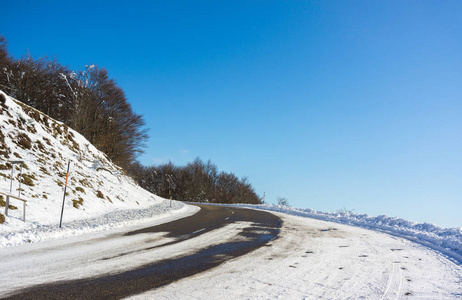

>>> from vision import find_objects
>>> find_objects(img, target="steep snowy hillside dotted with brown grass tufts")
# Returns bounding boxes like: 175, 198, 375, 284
0, 91, 184, 246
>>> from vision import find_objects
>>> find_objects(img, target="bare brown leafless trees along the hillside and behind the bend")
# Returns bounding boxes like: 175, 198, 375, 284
0, 35, 261, 203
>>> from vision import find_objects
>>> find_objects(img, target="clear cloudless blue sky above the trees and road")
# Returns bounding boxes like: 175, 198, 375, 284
0, 0, 462, 227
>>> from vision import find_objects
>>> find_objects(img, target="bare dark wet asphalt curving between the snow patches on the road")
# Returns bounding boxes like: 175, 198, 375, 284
3, 205, 282, 299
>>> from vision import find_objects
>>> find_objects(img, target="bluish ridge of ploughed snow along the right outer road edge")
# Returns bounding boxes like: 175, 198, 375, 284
238, 204, 462, 264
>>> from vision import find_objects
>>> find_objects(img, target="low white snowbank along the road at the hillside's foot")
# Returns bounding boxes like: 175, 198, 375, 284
0, 201, 199, 247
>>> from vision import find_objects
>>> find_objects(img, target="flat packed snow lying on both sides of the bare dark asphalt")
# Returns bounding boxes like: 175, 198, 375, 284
0, 206, 462, 299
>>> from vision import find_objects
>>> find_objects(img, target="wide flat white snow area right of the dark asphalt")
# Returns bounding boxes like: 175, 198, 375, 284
130, 213, 462, 300
